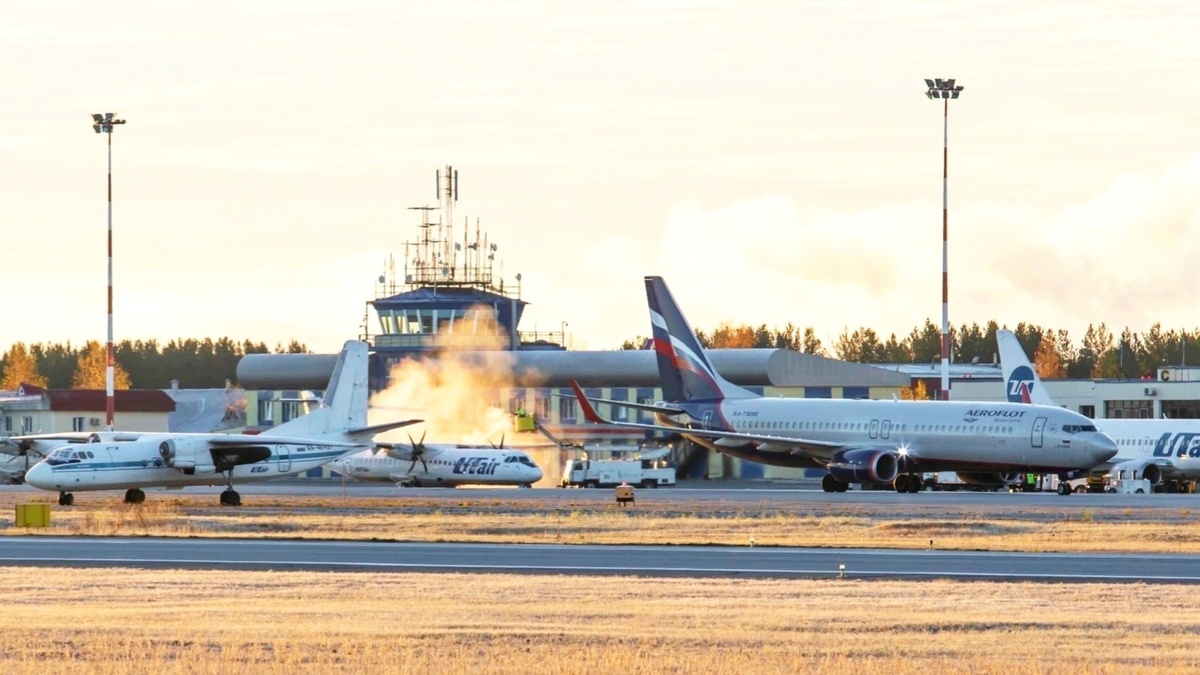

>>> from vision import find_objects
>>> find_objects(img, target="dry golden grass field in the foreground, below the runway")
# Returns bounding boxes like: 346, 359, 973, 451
0, 568, 1200, 675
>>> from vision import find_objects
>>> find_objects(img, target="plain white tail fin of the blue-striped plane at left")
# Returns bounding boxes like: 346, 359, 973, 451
265, 340, 370, 437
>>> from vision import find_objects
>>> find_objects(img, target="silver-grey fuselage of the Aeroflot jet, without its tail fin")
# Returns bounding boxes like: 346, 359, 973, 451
698, 398, 1116, 471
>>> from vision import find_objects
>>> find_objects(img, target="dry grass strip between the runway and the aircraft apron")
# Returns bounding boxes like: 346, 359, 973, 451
0, 490, 1200, 552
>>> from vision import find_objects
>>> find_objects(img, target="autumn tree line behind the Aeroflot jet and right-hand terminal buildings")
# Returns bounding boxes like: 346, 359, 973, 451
622, 319, 1200, 380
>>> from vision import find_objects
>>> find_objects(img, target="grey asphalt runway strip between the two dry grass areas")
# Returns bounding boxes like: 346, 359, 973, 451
0, 537, 1200, 584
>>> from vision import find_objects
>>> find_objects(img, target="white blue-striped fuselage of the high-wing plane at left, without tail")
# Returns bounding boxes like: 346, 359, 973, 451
25, 436, 360, 492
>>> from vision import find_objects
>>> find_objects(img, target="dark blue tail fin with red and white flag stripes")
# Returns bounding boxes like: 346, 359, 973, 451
646, 276, 754, 401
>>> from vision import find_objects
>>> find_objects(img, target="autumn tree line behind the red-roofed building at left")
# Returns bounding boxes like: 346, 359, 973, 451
0, 338, 308, 392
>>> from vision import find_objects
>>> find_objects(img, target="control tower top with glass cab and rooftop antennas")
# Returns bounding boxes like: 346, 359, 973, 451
362, 166, 564, 368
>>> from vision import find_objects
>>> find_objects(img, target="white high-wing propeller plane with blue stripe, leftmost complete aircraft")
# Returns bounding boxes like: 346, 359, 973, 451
12, 340, 420, 506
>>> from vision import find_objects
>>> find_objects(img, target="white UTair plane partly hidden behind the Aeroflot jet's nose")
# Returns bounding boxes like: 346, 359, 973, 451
996, 329, 1200, 494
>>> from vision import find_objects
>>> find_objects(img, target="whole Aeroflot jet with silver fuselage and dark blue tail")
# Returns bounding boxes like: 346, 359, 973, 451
572, 276, 1117, 492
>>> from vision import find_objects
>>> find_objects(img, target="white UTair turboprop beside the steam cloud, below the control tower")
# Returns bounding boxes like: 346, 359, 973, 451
329, 436, 541, 488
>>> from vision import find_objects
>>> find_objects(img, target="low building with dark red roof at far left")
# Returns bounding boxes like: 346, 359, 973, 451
0, 384, 175, 436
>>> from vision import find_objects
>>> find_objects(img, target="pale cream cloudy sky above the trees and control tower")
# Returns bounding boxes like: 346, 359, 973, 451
0, 0, 1200, 353
